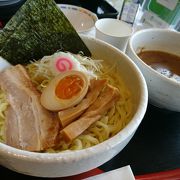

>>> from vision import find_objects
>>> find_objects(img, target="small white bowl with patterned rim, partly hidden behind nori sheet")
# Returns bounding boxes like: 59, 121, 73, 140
58, 4, 98, 33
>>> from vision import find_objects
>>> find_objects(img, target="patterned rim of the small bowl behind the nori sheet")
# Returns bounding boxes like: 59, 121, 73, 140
57, 4, 98, 33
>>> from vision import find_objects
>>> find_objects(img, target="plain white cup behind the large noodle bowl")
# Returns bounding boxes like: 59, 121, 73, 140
95, 18, 132, 52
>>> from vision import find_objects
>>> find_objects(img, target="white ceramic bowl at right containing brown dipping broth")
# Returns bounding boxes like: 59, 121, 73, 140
126, 29, 180, 112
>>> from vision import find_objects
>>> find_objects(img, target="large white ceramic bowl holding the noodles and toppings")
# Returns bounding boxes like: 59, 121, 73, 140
0, 37, 148, 177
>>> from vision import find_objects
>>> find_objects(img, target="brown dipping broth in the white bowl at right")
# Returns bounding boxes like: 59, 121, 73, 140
137, 50, 180, 81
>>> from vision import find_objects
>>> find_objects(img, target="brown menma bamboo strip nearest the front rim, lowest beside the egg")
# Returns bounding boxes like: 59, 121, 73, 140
60, 84, 120, 142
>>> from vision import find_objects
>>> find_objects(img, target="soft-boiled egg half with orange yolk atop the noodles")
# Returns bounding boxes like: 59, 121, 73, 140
40, 70, 89, 111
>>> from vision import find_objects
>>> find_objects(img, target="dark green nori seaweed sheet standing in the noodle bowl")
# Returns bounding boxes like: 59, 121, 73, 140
0, 0, 91, 64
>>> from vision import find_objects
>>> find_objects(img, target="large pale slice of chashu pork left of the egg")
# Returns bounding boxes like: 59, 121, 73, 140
0, 65, 59, 151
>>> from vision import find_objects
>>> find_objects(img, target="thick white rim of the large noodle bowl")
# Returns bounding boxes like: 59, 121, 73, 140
0, 35, 148, 163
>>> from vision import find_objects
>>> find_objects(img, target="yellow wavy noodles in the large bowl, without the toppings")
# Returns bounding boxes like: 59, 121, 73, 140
0, 54, 132, 152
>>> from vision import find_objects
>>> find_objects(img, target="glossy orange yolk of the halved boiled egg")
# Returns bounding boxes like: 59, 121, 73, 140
55, 75, 84, 99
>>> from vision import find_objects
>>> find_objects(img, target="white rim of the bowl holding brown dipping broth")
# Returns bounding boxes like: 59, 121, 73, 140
128, 28, 180, 87
